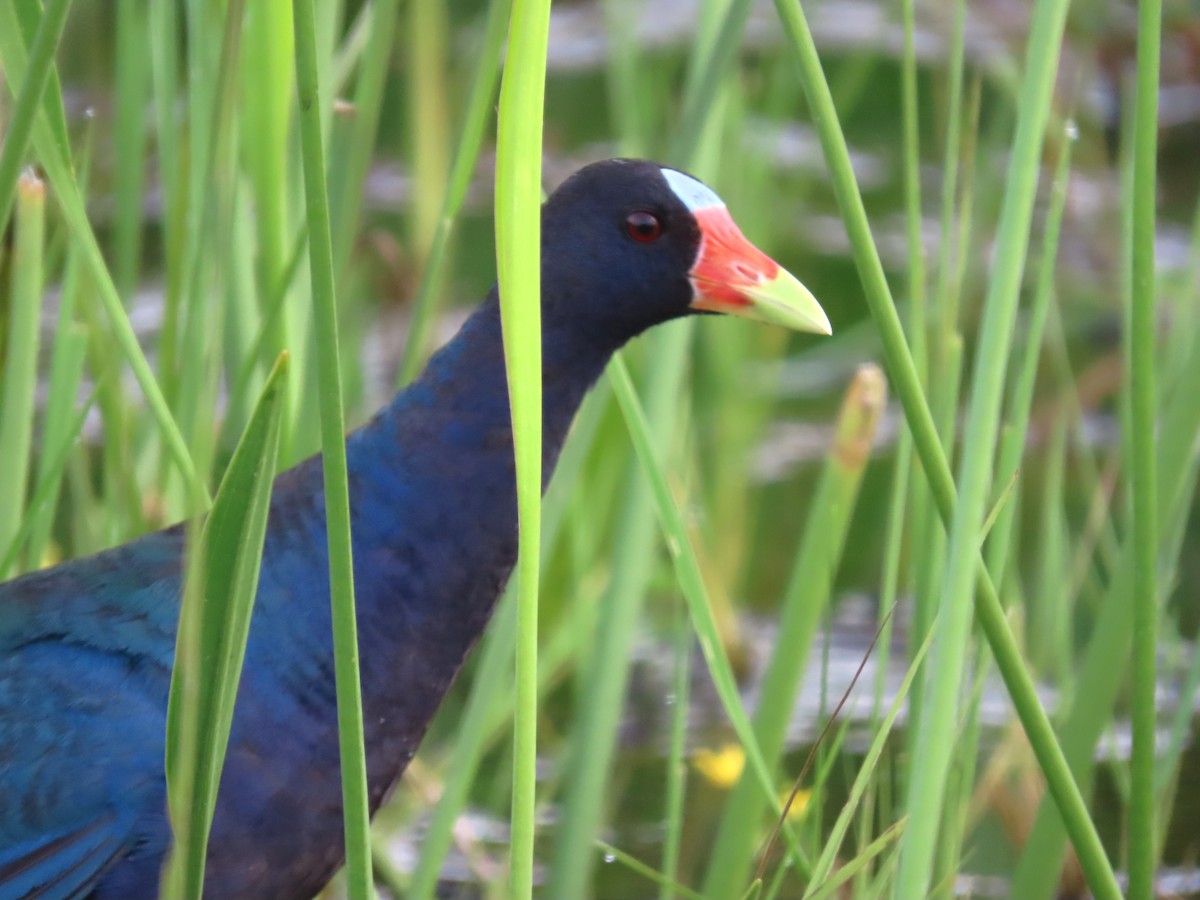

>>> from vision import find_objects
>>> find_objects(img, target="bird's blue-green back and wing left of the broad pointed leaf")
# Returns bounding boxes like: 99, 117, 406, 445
0, 529, 182, 900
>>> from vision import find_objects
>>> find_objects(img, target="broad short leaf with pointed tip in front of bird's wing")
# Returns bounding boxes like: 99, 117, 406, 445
163, 356, 288, 899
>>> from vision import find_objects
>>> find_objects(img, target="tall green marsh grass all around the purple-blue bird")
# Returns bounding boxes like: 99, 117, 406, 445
0, 0, 1200, 898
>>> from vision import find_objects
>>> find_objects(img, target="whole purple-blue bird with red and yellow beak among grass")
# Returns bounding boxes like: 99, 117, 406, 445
0, 160, 832, 900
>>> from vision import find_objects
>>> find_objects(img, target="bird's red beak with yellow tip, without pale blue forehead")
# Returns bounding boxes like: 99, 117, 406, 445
688, 206, 833, 335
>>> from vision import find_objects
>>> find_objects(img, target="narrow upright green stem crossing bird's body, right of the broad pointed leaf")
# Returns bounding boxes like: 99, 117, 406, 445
293, 0, 373, 900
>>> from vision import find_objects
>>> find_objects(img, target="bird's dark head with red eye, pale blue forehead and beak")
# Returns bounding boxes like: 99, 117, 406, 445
541, 160, 832, 344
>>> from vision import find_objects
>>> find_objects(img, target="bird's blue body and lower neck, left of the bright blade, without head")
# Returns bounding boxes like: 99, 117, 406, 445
0, 308, 530, 900
